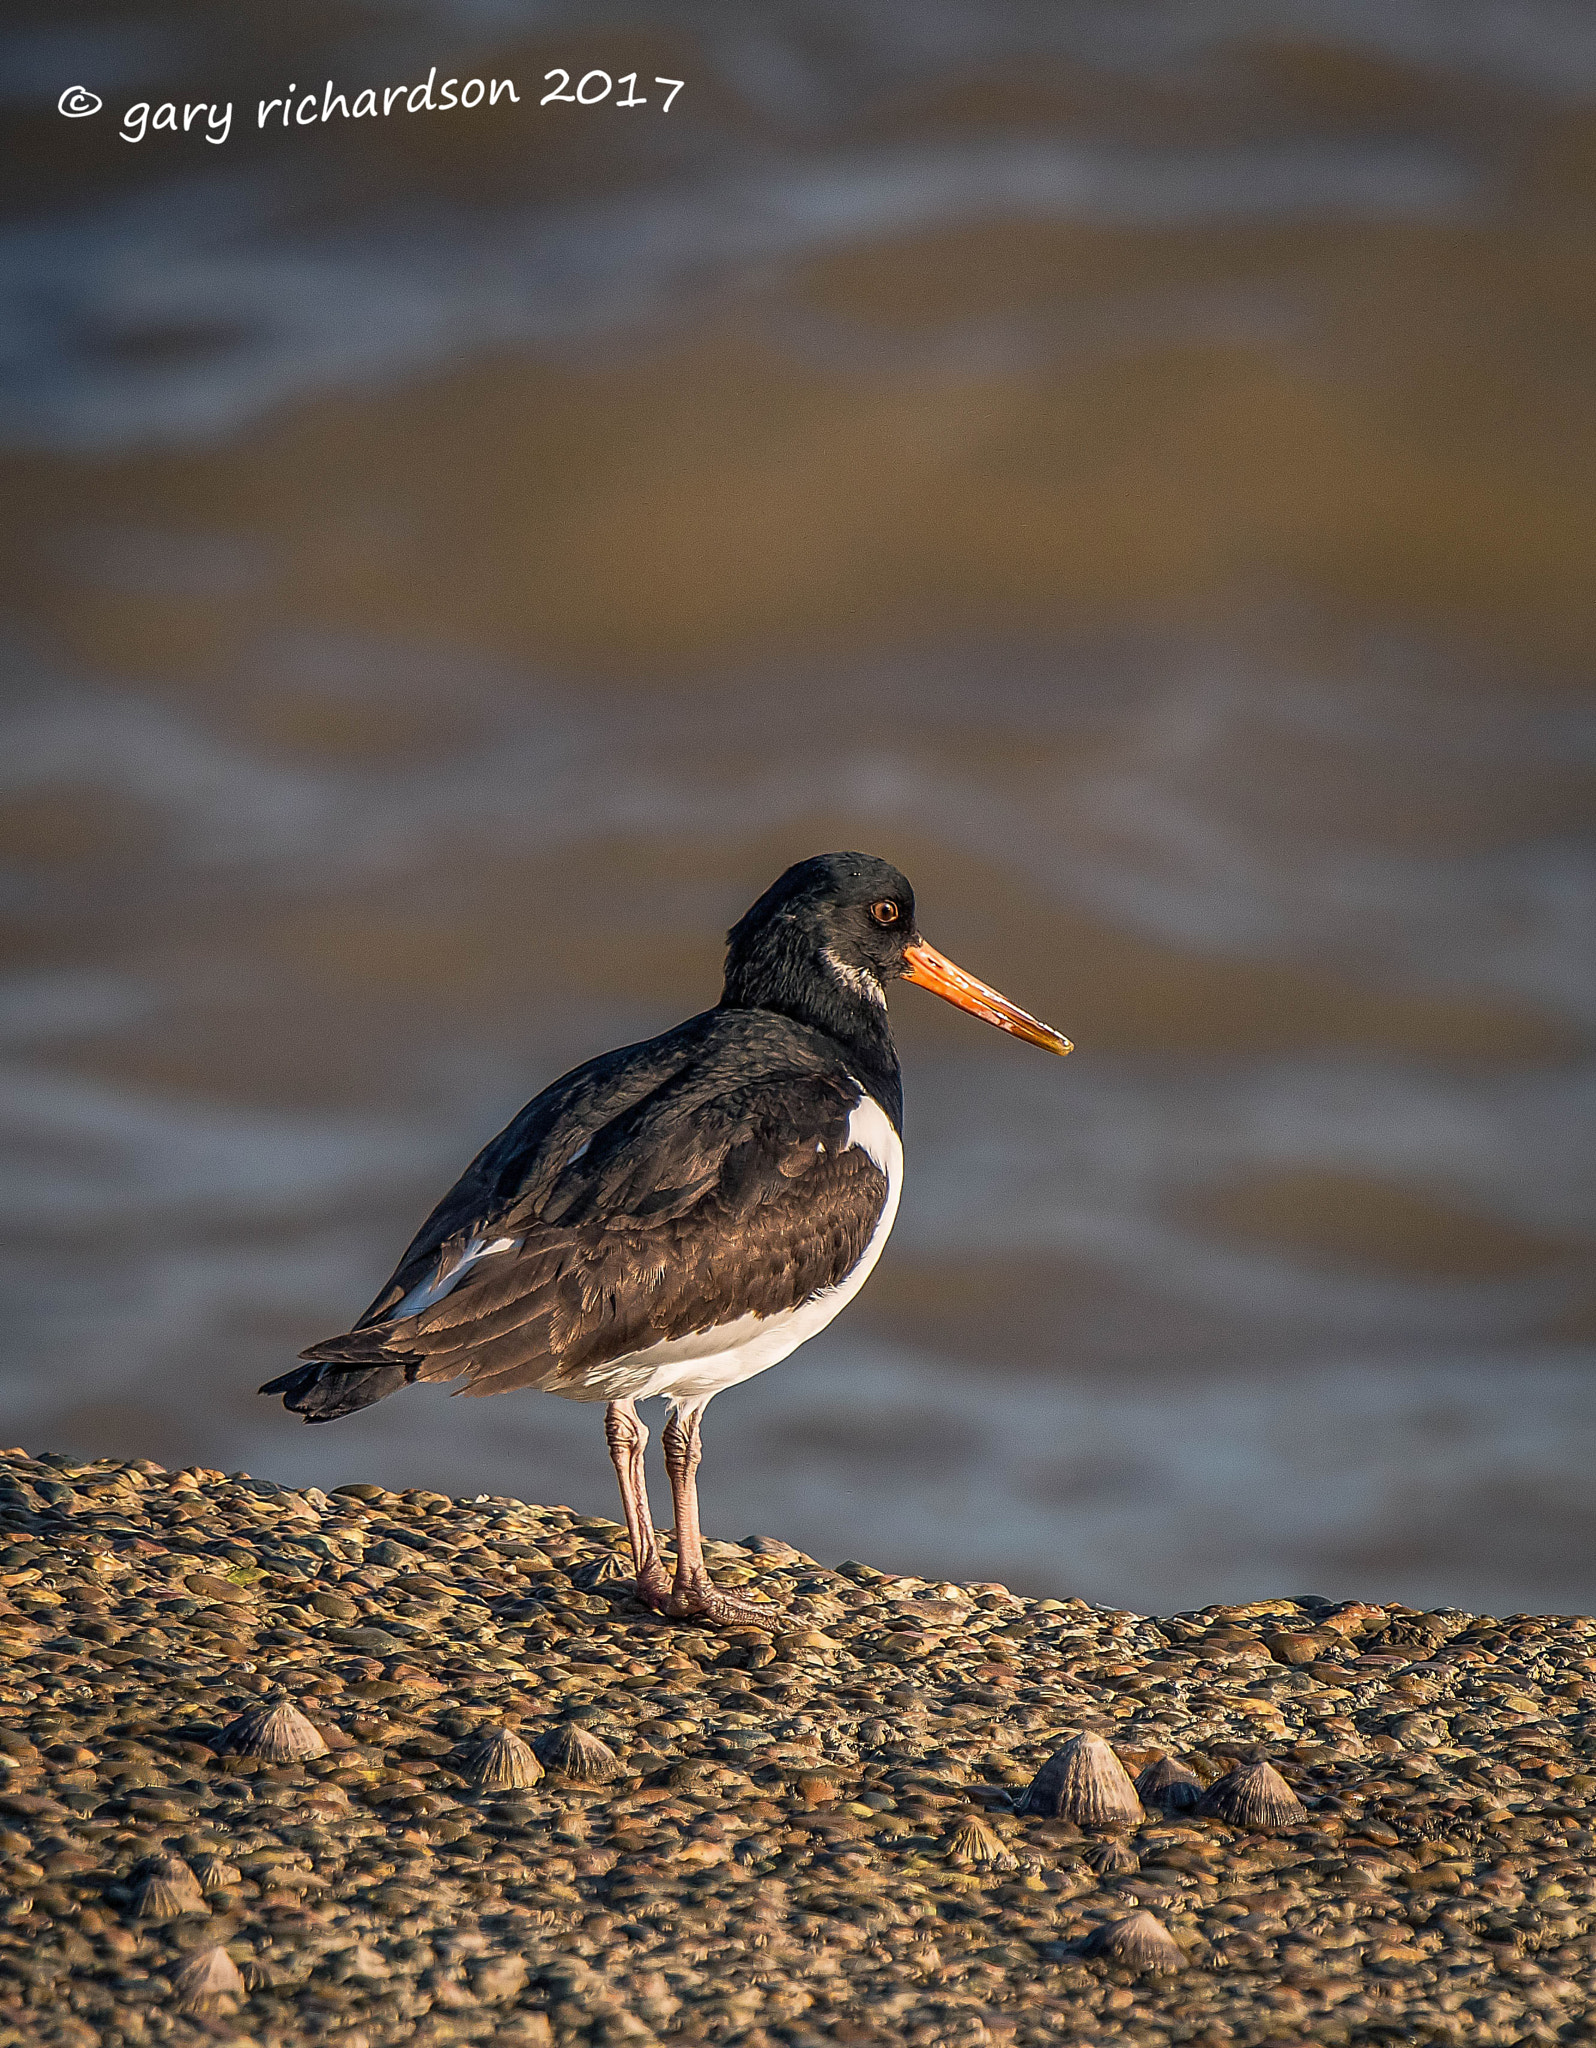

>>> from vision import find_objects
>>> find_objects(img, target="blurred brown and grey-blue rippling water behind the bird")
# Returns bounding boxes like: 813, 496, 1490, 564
0, 0, 1596, 1610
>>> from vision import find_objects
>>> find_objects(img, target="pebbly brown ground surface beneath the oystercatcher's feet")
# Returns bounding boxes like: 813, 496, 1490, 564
0, 1452, 1596, 2048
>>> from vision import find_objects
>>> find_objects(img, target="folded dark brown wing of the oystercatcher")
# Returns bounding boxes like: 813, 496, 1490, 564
303, 1020, 887, 1393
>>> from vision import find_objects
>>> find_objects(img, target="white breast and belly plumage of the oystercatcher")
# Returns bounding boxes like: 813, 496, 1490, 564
565, 1090, 904, 1411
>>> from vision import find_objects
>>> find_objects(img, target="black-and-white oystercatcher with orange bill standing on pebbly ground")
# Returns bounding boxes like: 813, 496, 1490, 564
260, 854, 1069, 1624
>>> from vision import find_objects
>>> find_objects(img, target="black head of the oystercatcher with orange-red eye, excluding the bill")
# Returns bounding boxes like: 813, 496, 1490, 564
721, 854, 916, 1036
